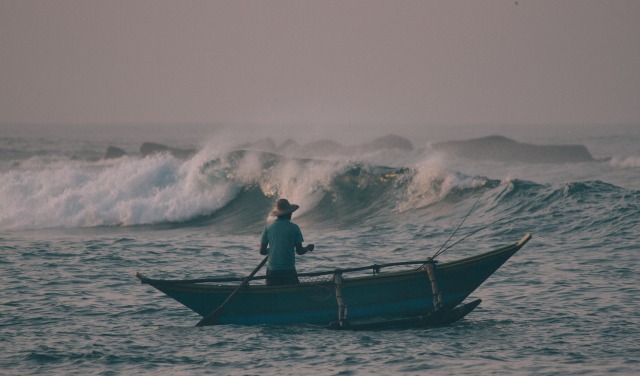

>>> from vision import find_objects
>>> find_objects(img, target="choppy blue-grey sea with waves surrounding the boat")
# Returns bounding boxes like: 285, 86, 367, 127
0, 124, 640, 375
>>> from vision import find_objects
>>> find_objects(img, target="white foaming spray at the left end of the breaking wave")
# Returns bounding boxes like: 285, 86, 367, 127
0, 155, 237, 229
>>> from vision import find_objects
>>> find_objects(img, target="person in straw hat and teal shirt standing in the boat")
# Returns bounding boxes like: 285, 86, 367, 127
260, 198, 314, 286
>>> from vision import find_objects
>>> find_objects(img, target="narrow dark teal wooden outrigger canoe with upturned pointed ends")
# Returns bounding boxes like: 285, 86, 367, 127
136, 234, 531, 329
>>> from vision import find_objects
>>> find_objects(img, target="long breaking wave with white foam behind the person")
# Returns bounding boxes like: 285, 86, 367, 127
0, 148, 631, 231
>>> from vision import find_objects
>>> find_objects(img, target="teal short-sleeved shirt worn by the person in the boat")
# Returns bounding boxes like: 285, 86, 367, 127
261, 218, 304, 270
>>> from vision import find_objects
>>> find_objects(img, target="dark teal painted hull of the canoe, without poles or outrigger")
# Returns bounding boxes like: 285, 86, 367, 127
137, 234, 530, 325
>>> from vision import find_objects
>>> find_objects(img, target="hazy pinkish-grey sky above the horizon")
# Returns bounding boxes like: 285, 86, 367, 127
0, 0, 640, 129
